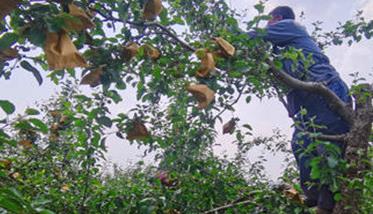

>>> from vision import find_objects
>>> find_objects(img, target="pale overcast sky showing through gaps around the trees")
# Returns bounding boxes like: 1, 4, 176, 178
0, 0, 373, 179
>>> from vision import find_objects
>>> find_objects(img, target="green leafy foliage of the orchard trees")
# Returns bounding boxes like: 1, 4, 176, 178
0, 0, 373, 213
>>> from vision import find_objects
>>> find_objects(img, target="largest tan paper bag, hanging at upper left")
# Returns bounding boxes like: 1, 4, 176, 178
44, 31, 87, 70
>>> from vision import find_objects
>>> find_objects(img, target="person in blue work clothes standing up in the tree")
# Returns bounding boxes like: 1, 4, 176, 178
248, 6, 351, 213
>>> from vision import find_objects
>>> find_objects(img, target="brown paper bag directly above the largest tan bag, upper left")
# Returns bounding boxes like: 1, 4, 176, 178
65, 4, 95, 31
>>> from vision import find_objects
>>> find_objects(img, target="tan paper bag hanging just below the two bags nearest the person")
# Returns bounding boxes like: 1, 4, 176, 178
187, 84, 215, 109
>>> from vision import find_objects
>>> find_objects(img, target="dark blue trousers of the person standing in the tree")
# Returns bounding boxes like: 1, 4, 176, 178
291, 78, 351, 210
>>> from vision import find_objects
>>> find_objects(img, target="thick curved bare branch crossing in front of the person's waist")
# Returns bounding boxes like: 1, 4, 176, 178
267, 60, 353, 125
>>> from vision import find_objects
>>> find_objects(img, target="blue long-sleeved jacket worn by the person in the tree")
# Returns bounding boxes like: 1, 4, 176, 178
248, 19, 348, 117
